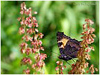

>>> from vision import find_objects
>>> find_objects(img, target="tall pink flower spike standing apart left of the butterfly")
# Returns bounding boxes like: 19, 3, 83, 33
18, 2, 47, 74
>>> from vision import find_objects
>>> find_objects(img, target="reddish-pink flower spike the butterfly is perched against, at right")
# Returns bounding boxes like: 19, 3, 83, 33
69, 19, 98, 74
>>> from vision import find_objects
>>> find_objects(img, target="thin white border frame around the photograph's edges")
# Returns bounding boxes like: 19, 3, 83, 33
0, 0, 100, 75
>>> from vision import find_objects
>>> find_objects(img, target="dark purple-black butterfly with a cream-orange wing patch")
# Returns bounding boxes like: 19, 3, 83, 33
57, 32, 81, 61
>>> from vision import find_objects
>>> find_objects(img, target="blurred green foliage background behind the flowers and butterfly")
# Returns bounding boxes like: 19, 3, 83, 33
1, 1, 99, 74
